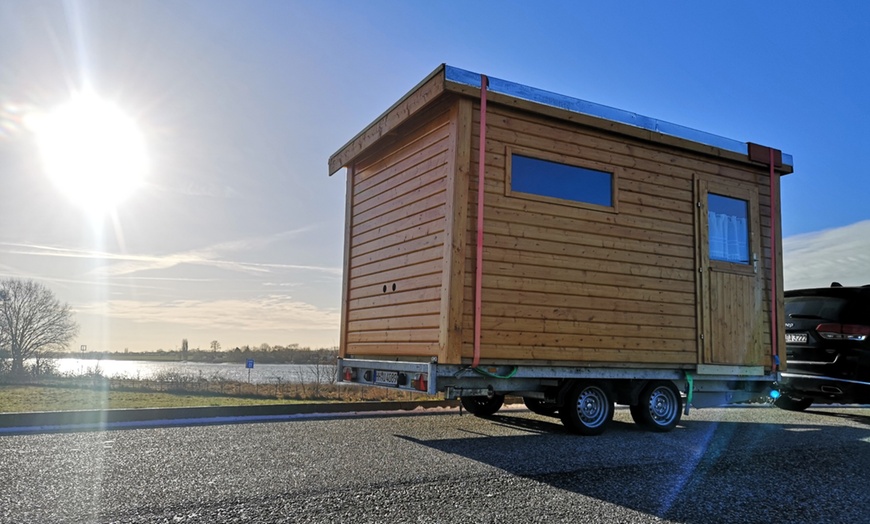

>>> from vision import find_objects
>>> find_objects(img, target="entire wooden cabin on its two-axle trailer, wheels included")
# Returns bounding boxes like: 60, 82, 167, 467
329, 65, 793, 434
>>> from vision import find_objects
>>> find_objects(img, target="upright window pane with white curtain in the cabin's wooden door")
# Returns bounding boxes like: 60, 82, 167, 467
707, 193, 749, 264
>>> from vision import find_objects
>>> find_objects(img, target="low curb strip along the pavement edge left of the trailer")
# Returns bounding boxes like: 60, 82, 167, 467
0, 400, 459, 429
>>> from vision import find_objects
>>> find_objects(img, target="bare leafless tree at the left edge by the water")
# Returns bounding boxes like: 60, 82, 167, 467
0, 279, 79, 373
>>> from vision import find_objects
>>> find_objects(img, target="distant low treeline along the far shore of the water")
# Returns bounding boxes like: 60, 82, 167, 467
43, 344, 338, 364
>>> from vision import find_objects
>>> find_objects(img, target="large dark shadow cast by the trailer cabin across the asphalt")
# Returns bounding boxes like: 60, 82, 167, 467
397, 408, 870, 524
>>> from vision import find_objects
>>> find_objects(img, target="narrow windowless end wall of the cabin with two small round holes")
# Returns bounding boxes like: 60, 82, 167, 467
341, 103, 455, 357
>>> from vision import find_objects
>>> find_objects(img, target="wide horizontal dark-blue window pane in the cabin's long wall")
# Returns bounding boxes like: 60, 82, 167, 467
511, 155, 613, 207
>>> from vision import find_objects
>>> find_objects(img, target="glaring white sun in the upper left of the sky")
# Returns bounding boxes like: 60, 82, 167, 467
34, 93, 148, 215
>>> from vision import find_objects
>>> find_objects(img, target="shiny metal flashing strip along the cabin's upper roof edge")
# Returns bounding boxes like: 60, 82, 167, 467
444, 64, 794, 167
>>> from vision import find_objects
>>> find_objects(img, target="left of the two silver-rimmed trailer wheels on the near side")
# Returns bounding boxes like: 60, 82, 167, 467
559, 381, 613, 435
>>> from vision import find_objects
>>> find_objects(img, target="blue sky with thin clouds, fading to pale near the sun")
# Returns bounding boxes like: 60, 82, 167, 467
0, 0, 870, 351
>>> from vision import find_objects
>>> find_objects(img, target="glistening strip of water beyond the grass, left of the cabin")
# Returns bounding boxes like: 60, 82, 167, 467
46, 358, 335, 384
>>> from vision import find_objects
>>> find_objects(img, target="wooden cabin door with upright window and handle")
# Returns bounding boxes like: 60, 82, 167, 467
696, 178, 765, 371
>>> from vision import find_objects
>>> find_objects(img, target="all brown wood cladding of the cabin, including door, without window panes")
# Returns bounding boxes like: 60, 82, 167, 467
329, 64, 790, 370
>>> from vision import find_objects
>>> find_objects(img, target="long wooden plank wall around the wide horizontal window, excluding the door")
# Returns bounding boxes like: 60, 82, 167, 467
462, 104, 770, 367
